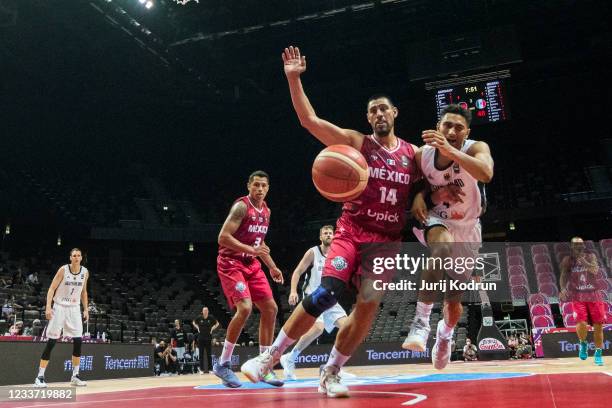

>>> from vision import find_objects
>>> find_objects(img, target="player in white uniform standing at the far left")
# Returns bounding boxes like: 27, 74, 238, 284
34, 248, 89, 387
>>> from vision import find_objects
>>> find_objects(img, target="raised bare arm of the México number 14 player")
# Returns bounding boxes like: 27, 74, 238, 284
282, 46, 364, 150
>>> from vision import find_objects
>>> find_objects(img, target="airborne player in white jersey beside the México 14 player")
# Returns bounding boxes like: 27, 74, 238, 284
402, 105, 493, 369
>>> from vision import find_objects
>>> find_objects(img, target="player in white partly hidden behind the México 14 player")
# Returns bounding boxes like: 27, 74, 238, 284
280, 225, 347, 380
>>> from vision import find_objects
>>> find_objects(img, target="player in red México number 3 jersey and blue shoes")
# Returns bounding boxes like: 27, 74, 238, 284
213, 171, 283, 388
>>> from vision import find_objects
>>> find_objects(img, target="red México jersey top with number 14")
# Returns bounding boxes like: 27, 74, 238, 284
342, 135, 420, 236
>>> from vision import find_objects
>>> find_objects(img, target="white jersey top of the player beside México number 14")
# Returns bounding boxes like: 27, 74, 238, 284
421, 139, 484, 225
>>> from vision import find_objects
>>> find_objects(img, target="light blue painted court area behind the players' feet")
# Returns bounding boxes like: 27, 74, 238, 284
194, 373, 532, 390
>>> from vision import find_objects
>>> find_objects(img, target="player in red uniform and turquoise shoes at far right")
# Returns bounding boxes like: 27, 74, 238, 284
559, 237, 606, 366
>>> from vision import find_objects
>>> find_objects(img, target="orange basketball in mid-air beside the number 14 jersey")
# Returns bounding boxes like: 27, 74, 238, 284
312, 145, 368, 202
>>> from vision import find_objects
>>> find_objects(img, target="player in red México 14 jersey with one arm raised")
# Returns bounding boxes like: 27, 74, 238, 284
241, 47, 419, 397
